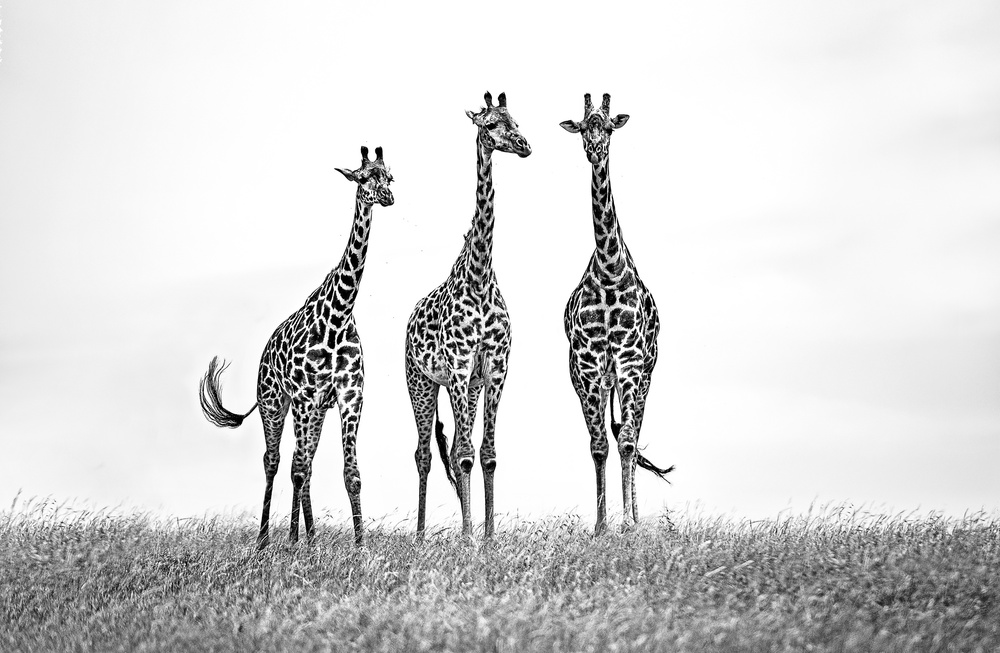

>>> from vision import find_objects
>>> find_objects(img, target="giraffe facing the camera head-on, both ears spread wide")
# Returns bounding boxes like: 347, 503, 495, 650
560, 93, 673, 534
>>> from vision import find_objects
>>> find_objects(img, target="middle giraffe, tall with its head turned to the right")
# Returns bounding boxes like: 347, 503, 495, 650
406, 93, 531, 539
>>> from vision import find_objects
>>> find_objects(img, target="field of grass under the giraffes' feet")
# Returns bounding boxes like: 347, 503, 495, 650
0, 503, 1000, 651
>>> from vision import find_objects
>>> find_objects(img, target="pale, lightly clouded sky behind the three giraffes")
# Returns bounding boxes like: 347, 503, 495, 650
0, 0, 1000, 527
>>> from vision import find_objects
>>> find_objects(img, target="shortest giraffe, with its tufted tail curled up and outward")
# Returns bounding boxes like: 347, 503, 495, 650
199, 147, 393, 549
